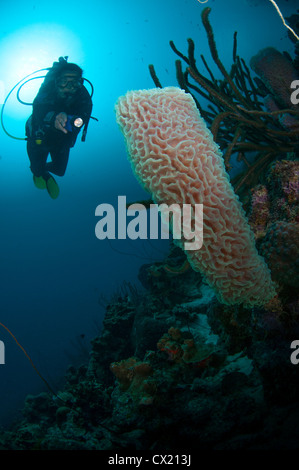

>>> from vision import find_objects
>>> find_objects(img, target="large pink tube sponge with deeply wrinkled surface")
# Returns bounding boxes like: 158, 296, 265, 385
116, 87, 275, 306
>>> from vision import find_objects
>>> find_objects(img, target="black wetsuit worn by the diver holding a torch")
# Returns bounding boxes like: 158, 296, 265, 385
26, 80, 92, 180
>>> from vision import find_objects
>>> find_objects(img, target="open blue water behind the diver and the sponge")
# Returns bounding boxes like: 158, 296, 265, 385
0, 0, 297, 426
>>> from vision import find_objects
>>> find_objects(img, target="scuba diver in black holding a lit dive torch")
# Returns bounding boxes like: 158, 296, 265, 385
26, 57, 92, 199
